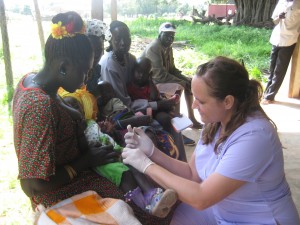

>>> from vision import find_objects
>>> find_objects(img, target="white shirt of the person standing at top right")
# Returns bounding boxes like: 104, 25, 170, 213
270, 0, 300, 46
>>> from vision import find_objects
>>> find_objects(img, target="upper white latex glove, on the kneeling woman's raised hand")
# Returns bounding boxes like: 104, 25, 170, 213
124, 125, 154, 157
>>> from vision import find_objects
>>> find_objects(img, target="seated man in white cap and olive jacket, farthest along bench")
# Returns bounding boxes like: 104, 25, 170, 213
142, 22, 202, 129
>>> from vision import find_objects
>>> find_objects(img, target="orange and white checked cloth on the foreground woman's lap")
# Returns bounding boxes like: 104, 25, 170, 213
35, 191, 141, 225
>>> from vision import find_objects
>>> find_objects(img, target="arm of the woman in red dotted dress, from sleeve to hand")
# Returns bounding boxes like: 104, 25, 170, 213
14, 97, 117, 197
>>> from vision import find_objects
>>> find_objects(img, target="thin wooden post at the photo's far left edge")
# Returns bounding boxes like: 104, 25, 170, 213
0, 0, 14, 107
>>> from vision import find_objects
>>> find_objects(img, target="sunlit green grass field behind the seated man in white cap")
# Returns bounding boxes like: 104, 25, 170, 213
128, 18, 271, 79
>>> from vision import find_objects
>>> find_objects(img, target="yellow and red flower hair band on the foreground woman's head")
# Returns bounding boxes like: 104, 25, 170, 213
51, 21, 85, 39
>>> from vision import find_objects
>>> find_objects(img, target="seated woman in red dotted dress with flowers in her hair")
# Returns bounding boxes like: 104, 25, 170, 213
13, 12, 170, 224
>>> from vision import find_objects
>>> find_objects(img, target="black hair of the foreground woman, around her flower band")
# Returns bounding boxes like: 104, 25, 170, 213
45, 11, 93, 66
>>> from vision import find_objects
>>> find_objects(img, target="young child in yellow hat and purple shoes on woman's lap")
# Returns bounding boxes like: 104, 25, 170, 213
62, 90, 177, 218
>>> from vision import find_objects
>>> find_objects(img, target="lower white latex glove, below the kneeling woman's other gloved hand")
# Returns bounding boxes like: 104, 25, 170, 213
122, 147, 154, 173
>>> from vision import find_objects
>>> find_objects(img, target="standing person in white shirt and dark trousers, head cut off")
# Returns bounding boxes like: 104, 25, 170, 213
261, 0, 300, 105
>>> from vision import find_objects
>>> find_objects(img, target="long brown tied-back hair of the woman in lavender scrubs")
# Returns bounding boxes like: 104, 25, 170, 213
196, 56, 276, 151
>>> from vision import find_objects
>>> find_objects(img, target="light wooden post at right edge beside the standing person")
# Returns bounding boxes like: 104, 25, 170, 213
288, 36, 300, 98
